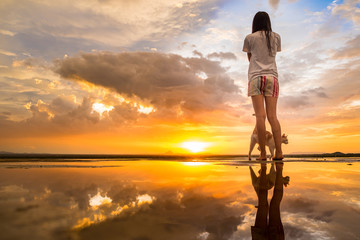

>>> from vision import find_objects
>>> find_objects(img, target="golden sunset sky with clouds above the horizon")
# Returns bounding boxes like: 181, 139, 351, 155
0, 0, 360, 154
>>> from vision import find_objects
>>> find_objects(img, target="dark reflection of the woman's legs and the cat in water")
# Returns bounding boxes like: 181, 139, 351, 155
250, 162, 289, 240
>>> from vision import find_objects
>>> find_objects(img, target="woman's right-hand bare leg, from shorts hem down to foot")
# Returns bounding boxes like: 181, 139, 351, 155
265, 96, 283, 159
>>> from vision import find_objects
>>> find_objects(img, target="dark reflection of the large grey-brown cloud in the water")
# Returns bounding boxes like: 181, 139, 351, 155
68, 190, 248, 240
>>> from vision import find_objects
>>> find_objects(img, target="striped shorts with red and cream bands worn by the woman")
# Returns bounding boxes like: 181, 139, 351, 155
248, 75, 279, 97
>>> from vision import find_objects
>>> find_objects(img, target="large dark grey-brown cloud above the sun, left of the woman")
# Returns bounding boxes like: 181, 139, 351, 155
55, 52, 238, 112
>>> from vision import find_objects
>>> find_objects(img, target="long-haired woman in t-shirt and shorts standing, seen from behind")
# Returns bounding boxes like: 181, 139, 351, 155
243, 12, 283, 160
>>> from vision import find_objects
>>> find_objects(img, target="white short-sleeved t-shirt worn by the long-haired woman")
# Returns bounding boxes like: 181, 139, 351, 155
243, 31, 281, 81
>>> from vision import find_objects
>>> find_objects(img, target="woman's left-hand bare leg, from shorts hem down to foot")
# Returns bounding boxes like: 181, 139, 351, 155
251, 95, 266, 160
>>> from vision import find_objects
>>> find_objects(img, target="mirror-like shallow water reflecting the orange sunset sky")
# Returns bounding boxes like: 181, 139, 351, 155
0, 158, 360, 240
